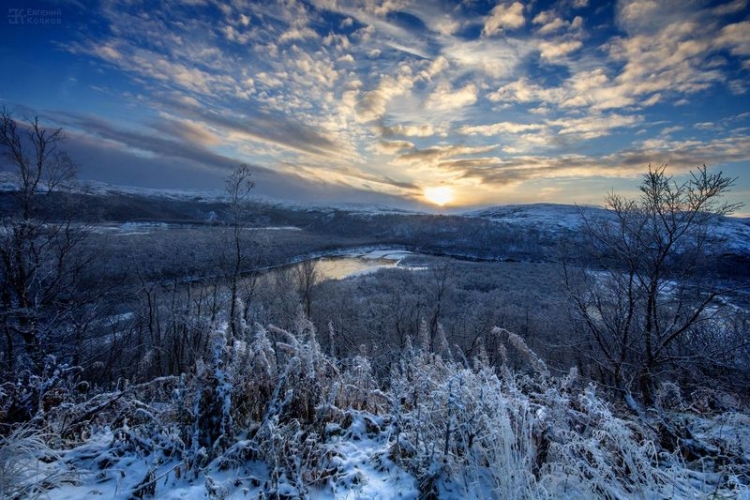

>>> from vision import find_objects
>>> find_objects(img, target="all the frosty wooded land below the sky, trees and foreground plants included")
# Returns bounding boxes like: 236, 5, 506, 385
0, 110, 750, 499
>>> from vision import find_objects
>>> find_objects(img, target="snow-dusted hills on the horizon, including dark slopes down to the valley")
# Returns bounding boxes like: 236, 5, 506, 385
0, 172, 750, 269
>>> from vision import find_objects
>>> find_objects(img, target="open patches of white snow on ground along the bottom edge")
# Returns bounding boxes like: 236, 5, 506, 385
49, 414, 419, 500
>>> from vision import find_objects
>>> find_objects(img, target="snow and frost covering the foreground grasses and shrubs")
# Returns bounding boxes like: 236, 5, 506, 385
10, 352, 750, 500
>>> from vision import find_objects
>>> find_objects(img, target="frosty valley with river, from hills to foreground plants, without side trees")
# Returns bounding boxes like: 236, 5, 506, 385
0, 178, 750, 498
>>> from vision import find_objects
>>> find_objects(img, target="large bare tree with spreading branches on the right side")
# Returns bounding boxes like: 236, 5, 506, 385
567, 166, 737, 406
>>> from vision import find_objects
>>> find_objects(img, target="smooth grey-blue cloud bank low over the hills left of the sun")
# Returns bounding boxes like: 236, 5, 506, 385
48, 114, 428, 208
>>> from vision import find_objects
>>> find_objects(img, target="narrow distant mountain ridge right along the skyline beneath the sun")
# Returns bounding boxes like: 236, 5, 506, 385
0, 172, 750, 254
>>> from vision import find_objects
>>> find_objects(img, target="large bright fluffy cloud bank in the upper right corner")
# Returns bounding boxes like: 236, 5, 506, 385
488, 1, 750, 111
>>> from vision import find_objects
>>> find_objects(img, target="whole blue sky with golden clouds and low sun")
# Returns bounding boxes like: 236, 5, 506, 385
0, 0, 750, 213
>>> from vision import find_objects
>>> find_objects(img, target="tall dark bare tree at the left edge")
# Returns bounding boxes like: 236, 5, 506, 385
0, 108, 89, 376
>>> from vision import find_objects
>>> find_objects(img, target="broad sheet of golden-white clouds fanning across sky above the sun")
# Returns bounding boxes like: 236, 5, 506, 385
23, 0, 750, 207
